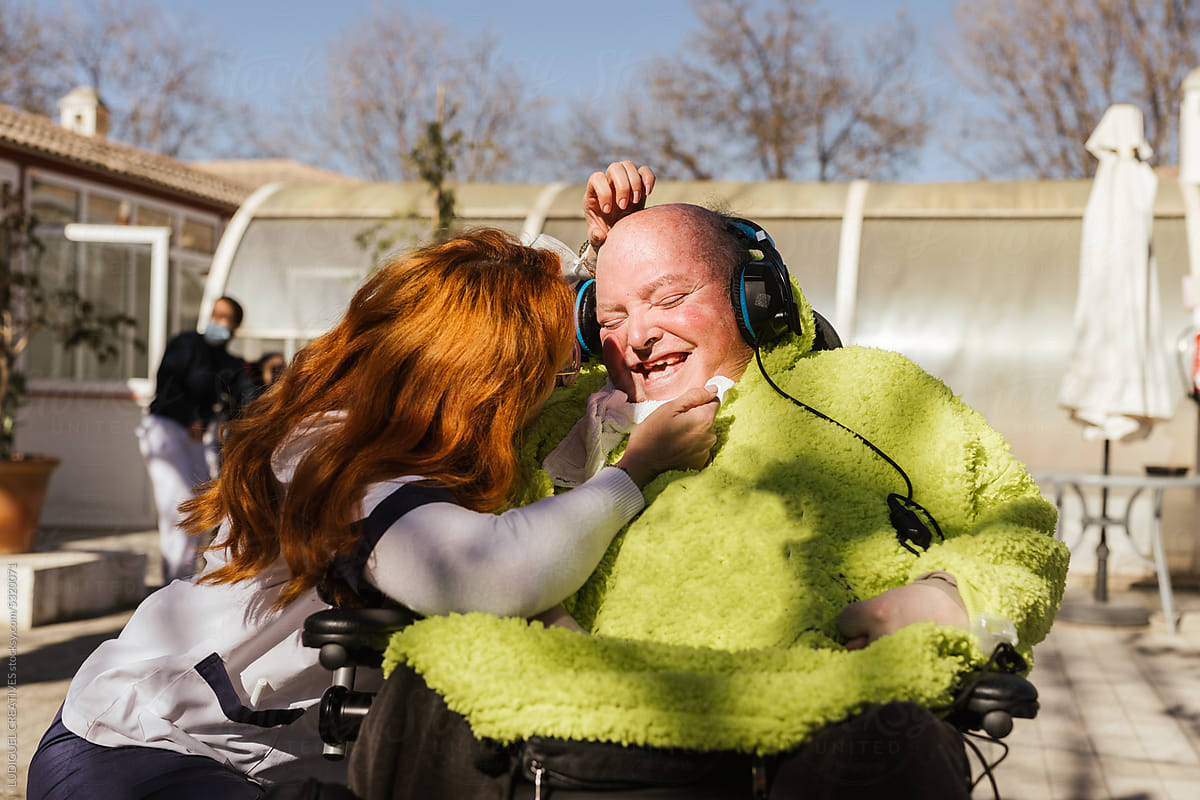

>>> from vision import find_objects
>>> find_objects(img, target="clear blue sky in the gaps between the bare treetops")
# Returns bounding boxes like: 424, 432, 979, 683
164, 0, 967, 181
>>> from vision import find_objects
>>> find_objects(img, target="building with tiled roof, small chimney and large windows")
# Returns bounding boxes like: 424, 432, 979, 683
0, 89, 250, 529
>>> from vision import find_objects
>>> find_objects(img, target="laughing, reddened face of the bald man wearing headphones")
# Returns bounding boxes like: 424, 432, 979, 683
596, 205, 752, 402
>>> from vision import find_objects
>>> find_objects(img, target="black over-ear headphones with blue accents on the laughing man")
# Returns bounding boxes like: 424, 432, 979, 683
575, 217, 803, 357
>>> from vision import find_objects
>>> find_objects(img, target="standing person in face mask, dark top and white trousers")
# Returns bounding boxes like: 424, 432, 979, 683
138, 297, 256, 584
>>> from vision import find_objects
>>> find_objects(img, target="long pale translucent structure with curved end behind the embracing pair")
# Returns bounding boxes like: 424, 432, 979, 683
23, 179, 1200, 585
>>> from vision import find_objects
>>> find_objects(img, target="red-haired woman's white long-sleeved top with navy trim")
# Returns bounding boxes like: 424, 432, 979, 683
62, 419, 643, 782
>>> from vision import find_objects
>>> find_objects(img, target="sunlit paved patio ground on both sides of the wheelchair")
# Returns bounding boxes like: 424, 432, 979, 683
9, 534, 1200, 800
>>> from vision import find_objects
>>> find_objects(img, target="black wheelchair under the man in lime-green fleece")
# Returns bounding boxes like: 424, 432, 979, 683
285, 312, 1038, 800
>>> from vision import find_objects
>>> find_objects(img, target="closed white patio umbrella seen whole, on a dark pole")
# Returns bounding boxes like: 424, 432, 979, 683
1058, 104, 1178, 602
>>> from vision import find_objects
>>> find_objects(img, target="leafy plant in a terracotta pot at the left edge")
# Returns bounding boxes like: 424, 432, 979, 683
0, 184, 134, 553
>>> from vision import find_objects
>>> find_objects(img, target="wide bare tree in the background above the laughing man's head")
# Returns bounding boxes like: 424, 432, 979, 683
544, 0, 926, 181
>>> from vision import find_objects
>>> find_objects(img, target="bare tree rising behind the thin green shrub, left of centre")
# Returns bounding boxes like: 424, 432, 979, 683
300, 10, 544, 180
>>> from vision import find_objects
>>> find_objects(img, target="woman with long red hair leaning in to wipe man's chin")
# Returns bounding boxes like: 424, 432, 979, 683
29, 229, 715, 800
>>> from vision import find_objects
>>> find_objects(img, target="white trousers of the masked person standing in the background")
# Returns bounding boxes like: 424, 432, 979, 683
138, 414, 209, 585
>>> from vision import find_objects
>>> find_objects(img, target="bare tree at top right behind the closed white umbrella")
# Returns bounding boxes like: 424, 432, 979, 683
952, 0, 1200, 178
